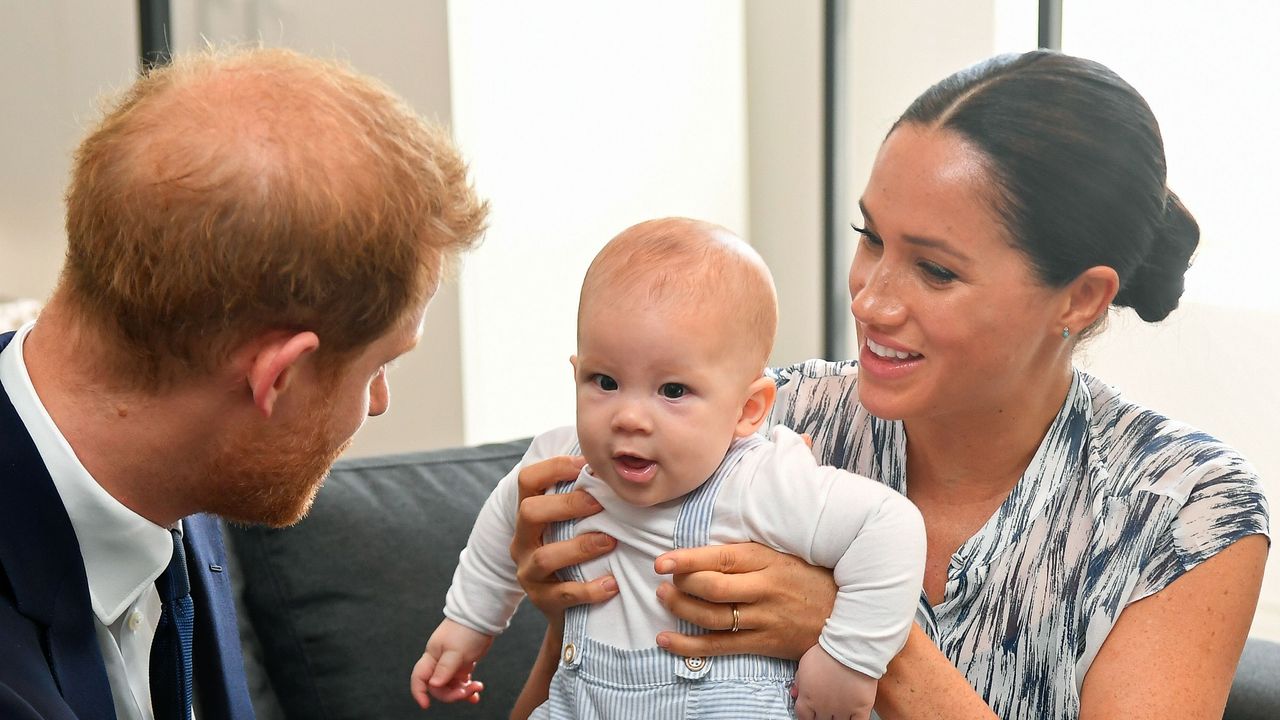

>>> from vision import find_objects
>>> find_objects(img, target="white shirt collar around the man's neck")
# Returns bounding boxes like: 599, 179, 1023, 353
0, 322, 173, 625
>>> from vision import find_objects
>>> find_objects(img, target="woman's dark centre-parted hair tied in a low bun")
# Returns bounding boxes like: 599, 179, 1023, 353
891, 50, 1199, 322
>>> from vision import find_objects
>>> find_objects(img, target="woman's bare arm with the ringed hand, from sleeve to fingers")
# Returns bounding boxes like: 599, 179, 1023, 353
659, 536, 1267, 720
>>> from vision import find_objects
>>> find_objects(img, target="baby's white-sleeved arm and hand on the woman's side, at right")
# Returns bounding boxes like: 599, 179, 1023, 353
739, 429, 925, 716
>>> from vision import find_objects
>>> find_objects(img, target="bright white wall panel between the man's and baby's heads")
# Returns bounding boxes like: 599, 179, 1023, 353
449, 0, 748, 442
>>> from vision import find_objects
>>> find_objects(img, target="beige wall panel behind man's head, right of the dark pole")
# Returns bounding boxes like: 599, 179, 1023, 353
172, 0, 463, 456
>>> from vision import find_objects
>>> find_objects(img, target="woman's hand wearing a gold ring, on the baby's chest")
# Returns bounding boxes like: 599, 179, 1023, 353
654, 543, 836, 660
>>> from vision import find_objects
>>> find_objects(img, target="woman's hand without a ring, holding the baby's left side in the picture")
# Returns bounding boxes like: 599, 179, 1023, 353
511, 455, 618, 614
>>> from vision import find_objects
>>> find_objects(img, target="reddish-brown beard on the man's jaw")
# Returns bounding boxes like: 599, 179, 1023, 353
202, 392, 351, 528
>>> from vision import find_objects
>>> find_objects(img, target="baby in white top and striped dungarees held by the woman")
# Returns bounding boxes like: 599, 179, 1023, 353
411, 218, 924, 719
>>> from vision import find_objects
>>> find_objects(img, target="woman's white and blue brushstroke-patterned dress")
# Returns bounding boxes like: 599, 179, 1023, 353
771, 360, 1268, 719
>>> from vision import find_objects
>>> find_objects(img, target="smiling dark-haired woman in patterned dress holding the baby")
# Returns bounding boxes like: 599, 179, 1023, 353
513, 51, 1268, 719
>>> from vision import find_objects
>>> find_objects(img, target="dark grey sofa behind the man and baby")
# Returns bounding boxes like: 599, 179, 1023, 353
228, 441, 1280, 720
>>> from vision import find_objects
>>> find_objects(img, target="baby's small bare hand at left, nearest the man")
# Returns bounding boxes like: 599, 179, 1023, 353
408, 619, 493, 710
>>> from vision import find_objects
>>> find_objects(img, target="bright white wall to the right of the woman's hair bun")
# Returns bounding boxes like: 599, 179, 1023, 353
1062, 0, 1280, 639
